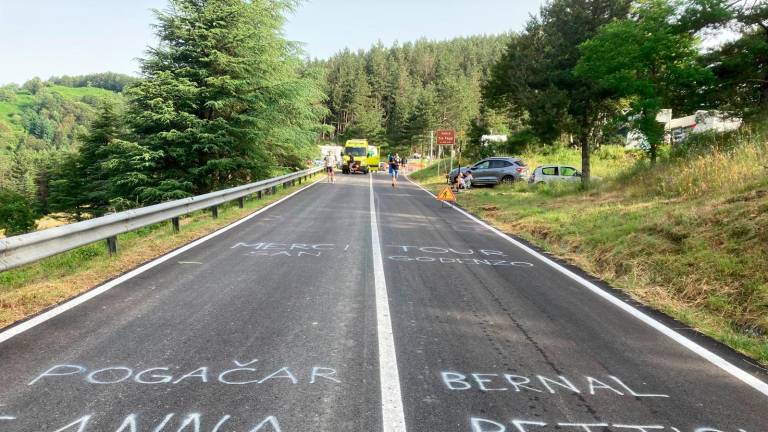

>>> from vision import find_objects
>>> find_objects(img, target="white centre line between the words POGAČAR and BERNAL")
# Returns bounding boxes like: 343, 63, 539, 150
368, 176, 412, 432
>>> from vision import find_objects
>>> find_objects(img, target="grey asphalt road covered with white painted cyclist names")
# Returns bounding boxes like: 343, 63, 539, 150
0, 174, 768, 432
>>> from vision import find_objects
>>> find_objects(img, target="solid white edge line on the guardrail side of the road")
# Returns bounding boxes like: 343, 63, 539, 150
0, 182, 317, 343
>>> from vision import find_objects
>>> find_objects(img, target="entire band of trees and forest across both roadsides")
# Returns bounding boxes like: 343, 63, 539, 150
0, 0, 768, 234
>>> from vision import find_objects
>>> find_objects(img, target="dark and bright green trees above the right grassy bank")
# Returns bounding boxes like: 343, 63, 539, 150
483, 0, 768, 182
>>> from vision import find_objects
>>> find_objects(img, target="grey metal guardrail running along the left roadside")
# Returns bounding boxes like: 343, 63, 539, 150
0, 167, 322, 271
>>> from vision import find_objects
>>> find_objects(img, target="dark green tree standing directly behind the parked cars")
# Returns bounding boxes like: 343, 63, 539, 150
483, 0, 630, 182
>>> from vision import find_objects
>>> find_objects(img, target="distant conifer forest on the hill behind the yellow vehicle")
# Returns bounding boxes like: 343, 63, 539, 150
317, 35, 508, 153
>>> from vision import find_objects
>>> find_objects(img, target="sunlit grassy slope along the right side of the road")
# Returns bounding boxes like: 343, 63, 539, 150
412, 126, 768, 365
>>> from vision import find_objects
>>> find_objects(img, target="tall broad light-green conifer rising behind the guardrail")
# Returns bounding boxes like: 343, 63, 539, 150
127, 0, 325, 203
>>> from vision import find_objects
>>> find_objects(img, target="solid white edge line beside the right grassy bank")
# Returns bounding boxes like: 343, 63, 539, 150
406, 177, 768, 396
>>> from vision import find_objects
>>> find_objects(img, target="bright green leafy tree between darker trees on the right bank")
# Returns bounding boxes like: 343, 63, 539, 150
576, 0, 712, 162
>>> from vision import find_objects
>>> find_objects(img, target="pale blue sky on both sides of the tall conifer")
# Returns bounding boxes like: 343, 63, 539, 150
0, 0, 543, 85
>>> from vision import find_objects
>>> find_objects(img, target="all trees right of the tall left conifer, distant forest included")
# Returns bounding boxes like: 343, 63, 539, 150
315, 0, 768, 182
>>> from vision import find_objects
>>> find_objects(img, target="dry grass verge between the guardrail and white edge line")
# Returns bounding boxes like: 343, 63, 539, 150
0, 176, 322, 328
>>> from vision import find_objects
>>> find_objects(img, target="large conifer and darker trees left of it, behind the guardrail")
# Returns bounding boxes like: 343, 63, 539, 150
0, 0, 326, 234
